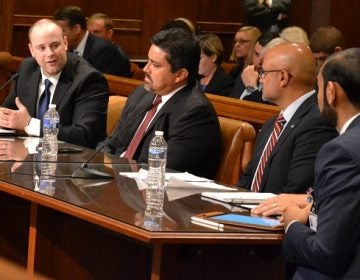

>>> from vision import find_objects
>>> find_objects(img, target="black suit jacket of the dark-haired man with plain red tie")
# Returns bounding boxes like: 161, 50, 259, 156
103, 85, 221, 178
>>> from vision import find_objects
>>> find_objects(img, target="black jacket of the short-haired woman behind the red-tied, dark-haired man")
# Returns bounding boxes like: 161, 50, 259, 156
204, 67, 234, 96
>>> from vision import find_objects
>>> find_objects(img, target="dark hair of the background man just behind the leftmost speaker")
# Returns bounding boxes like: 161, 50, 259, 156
54, 6, 87, 31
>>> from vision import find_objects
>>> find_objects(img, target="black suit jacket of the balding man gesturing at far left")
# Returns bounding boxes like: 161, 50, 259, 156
3, 53, 109, 148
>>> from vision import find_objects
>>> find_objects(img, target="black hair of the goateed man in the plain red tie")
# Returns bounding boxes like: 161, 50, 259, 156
150, 28, 200, 84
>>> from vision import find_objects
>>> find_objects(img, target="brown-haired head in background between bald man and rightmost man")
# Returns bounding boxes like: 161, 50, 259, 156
310, 26, 345, 71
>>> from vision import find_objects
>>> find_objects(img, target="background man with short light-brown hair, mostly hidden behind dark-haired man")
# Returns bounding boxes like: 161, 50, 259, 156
87, 13, 130, 71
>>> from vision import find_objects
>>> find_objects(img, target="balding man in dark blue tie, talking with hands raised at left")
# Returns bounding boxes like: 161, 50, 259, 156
0, 19, 109, 148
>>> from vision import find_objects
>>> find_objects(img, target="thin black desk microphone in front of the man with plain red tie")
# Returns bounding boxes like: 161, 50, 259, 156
71, 101, 153, 179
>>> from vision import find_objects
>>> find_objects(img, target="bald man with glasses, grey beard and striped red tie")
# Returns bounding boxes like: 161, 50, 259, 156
238, 43, 337, 193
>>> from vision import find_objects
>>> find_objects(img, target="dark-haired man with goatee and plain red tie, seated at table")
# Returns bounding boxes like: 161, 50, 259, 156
101, 28, 221, 178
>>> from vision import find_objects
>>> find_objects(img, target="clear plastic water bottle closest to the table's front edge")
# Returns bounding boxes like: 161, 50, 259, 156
145, 131, 167, 218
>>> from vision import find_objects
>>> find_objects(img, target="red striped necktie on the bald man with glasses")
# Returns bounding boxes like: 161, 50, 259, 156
251, 114, 286, 192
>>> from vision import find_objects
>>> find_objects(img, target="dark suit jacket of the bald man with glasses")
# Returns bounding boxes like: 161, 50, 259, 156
238, 94, 337, 193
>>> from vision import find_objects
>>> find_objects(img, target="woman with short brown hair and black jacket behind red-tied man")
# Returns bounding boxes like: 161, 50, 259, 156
199, 33, 234, 96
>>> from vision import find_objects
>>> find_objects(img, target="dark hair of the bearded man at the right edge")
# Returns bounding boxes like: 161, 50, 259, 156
322, 48, 360, 108
